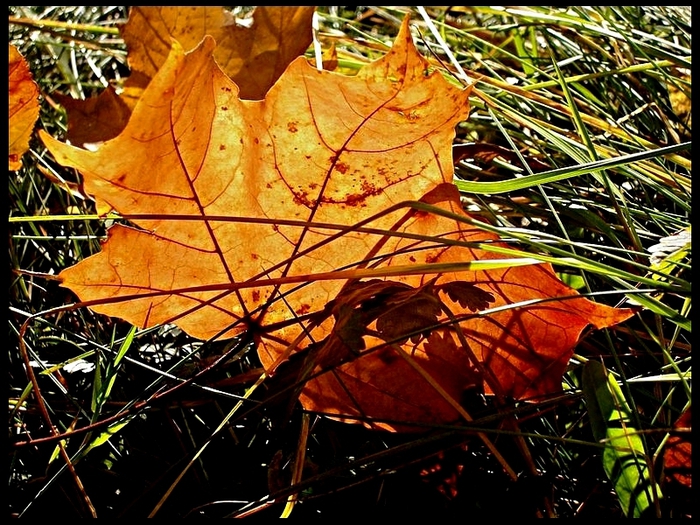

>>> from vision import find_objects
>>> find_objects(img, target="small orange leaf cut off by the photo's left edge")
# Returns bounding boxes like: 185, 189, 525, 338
8, 44, 39, 171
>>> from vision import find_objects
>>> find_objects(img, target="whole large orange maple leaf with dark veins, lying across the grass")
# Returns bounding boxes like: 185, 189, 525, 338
42, 21, 631, 430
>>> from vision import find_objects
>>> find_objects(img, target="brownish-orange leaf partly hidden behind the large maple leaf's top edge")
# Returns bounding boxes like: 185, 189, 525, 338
54, 6, 315, 156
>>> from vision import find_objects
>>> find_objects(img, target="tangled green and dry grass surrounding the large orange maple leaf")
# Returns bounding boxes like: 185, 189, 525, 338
8, 6, 691, 519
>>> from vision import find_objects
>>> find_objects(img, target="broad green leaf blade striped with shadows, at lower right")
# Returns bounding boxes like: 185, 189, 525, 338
582, 361, 662, 518
